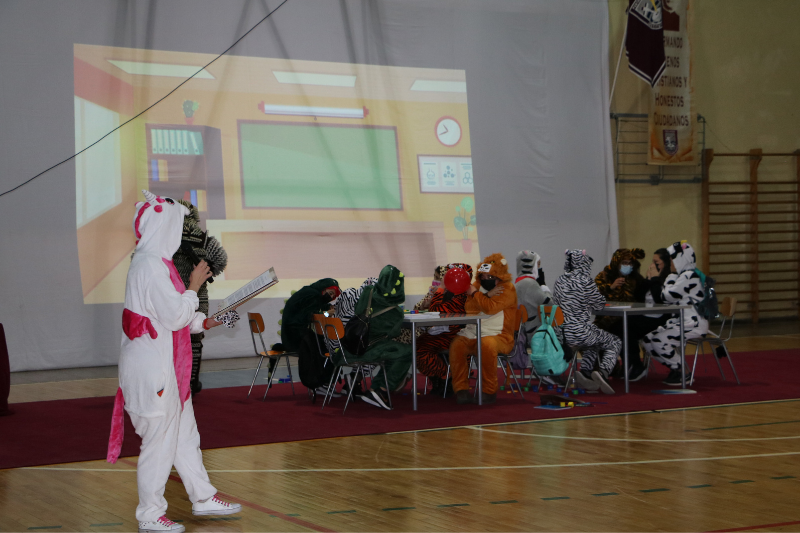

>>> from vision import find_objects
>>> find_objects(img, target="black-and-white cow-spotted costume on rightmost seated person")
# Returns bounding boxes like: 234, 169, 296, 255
642, 242, 708, 370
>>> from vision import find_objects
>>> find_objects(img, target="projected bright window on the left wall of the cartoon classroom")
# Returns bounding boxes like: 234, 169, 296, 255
75, 96, 122, 227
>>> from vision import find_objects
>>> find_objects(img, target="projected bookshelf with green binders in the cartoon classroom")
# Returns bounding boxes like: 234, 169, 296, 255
146, 124, 225, 222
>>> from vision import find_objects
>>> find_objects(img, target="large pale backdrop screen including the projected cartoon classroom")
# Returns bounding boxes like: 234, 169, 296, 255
0, 0, 617, 371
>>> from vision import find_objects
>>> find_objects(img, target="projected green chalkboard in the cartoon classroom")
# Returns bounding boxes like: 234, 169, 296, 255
239, 121, 402, 209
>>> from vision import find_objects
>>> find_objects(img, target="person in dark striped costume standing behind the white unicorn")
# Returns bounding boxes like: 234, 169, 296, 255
172, 200, 228, 394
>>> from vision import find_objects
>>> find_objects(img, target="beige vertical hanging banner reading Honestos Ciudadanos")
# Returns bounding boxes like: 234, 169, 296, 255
647, 0, 697, 165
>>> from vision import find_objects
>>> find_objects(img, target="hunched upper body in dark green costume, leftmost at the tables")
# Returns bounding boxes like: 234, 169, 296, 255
280, 278, 342, 352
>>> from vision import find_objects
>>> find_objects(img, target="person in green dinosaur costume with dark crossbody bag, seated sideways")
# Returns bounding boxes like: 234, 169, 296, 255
334, 265, 412, 409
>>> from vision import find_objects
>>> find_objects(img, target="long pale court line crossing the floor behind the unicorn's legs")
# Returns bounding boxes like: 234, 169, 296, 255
17, 452, 800, 474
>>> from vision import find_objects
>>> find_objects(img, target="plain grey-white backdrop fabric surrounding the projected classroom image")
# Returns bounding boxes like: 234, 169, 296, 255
0, 0, 618, 371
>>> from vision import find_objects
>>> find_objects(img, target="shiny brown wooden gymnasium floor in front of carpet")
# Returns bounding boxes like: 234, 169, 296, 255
0, 328, 800, 532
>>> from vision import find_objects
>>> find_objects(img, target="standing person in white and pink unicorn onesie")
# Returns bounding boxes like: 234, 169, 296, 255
107, 191, 241, 533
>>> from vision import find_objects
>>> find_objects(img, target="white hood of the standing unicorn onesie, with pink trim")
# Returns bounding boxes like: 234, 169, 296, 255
133, 189, 189, 261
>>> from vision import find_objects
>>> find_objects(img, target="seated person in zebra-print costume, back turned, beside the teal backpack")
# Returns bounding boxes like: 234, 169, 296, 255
553, 250, 622, 394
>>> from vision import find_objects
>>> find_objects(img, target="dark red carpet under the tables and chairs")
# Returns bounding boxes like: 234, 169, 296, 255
0, 349, 800, 468
